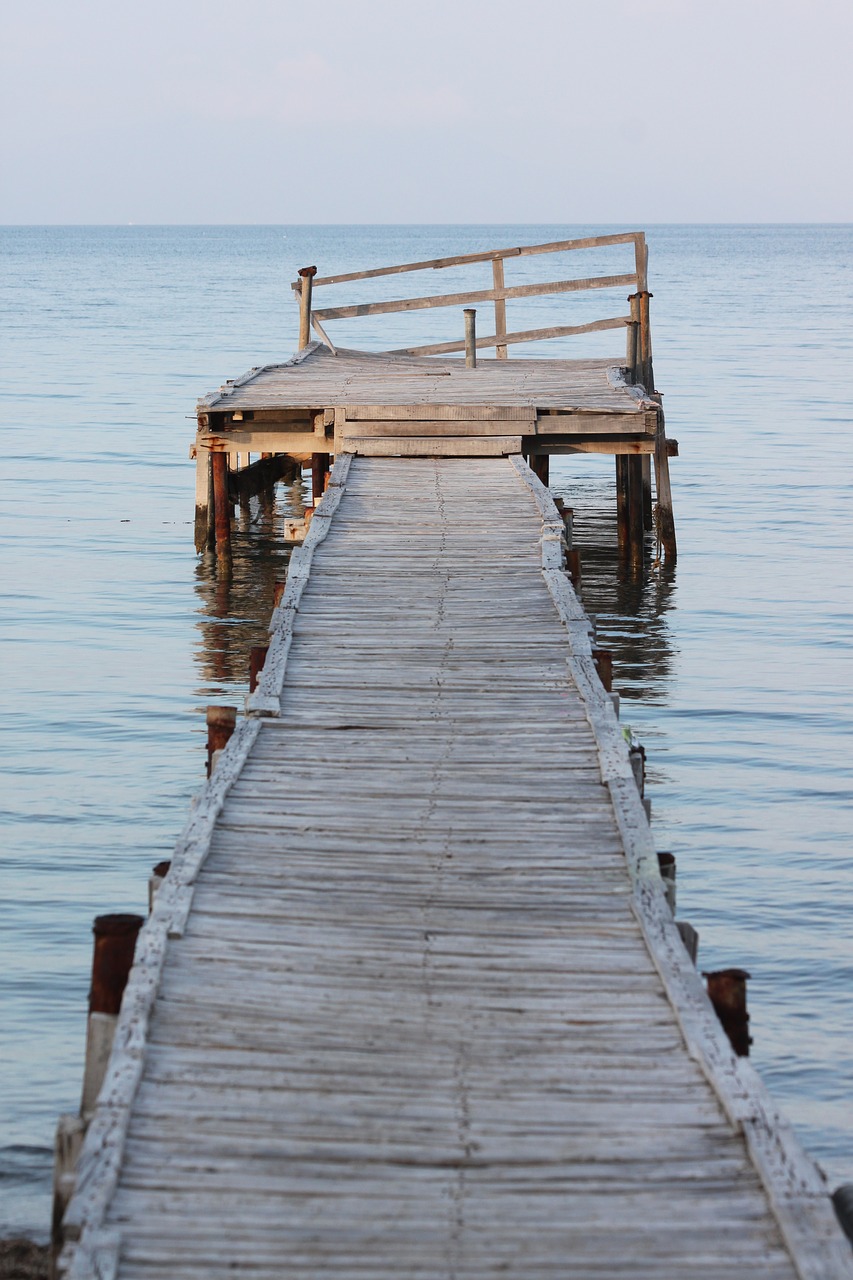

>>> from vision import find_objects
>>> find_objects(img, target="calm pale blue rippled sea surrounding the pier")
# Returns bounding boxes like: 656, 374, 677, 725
0, 227, 853, 1236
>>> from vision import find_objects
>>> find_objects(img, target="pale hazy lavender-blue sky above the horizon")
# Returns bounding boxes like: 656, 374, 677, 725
0, 0, 853, 223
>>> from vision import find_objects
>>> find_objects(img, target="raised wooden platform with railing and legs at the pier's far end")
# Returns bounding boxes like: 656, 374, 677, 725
192, 232, 678, 567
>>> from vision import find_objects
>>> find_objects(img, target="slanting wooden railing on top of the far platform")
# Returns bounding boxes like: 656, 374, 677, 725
292, 232, 652, 387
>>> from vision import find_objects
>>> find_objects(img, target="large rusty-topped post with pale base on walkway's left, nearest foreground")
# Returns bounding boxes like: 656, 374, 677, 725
79, 915, 145, 1119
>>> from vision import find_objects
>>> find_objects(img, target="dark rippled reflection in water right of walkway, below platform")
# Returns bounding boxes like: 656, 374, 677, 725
552, 458, 676, 703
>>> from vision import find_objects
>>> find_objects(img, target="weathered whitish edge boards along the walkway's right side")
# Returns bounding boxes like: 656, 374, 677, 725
510, 457, 853, 1280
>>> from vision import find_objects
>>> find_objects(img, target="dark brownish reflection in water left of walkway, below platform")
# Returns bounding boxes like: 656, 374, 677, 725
190, 480, 310, 703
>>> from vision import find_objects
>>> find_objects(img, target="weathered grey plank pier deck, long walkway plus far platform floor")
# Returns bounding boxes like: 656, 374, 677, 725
61, 238, 853, 1280
